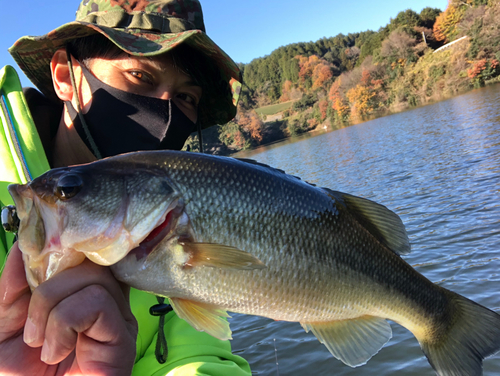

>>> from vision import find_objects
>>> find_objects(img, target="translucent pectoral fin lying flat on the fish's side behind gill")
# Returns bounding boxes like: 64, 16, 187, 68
179, 241, 266, 270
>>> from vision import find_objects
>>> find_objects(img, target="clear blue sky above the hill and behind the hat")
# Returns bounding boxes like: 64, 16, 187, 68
0, 0, 448, 86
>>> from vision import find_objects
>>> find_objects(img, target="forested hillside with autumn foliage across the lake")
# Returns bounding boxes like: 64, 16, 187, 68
191, 0, 500, 152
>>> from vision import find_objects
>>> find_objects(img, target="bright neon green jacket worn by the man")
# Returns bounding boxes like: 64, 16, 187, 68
0, 66, 251, 376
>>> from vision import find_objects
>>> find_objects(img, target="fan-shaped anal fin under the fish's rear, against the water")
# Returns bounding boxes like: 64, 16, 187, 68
300, 316, 392, 367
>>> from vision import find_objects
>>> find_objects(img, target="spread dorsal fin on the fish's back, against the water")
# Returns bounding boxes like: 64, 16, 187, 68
323, 188, 411, 255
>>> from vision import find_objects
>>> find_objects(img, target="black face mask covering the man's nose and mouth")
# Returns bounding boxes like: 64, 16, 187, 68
66, 64, 196, 158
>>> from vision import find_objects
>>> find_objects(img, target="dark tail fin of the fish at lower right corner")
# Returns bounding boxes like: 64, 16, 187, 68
419, 291, 500, 376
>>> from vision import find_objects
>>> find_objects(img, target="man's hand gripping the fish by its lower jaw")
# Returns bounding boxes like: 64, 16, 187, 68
0, 243, 137, 376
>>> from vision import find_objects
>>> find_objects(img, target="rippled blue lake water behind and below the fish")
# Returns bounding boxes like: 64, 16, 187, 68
231, 85, 500, 376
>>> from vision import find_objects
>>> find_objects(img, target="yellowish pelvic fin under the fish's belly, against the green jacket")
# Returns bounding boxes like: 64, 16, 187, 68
170, 298, 232, 341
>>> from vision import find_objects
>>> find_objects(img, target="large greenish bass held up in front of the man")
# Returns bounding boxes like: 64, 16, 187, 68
8, 151, 500, 376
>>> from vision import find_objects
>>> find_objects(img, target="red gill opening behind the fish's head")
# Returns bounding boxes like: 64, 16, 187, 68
126, 201, 187, 261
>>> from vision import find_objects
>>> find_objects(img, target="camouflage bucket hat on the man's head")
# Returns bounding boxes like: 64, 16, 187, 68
9, 0, 241, 128
